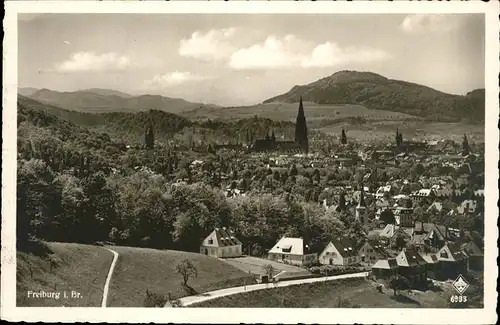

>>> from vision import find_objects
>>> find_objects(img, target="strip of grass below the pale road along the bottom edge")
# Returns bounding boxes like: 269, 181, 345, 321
196, 279, 449, 308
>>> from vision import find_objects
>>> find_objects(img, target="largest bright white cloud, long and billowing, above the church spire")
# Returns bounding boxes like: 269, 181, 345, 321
229, 35, 391, 70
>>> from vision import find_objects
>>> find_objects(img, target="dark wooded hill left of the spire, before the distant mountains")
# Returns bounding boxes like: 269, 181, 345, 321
18, 95, 294, 143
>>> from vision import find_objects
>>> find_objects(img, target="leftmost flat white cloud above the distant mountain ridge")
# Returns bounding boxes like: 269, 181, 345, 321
56, 52, 130, 72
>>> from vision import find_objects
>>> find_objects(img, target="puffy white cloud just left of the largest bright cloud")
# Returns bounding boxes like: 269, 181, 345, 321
179, 28, 236, 60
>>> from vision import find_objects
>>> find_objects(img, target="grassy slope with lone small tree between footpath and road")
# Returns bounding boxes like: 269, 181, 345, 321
108, 247, 254, 307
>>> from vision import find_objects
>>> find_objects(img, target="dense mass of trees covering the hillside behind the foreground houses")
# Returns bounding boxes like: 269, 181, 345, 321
17, 105, 484, 255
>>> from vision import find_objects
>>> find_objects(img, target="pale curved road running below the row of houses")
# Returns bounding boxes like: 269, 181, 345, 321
174, 272, 368, 307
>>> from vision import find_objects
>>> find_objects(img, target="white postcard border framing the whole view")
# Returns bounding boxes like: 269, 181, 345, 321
0, 1, 500, 324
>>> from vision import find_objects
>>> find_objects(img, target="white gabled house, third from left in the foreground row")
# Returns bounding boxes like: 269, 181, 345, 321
319, 239, 360, 266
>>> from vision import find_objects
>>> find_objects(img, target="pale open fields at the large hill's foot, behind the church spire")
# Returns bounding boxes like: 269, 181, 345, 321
181, 102, 484, 141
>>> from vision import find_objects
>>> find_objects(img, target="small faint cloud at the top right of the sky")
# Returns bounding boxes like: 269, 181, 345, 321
400, 14, 462, 34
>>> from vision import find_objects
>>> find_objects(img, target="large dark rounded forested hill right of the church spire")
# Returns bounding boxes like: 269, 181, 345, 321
264, 70, 485, 123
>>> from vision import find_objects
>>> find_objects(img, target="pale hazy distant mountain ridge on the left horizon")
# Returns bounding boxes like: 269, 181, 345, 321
23, 88, 217, 114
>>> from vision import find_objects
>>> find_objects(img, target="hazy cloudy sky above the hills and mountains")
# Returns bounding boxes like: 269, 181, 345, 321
19, 14, 485, 105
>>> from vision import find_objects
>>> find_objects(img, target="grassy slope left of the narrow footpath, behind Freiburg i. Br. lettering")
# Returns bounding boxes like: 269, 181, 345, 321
16, 243, 113, 307
